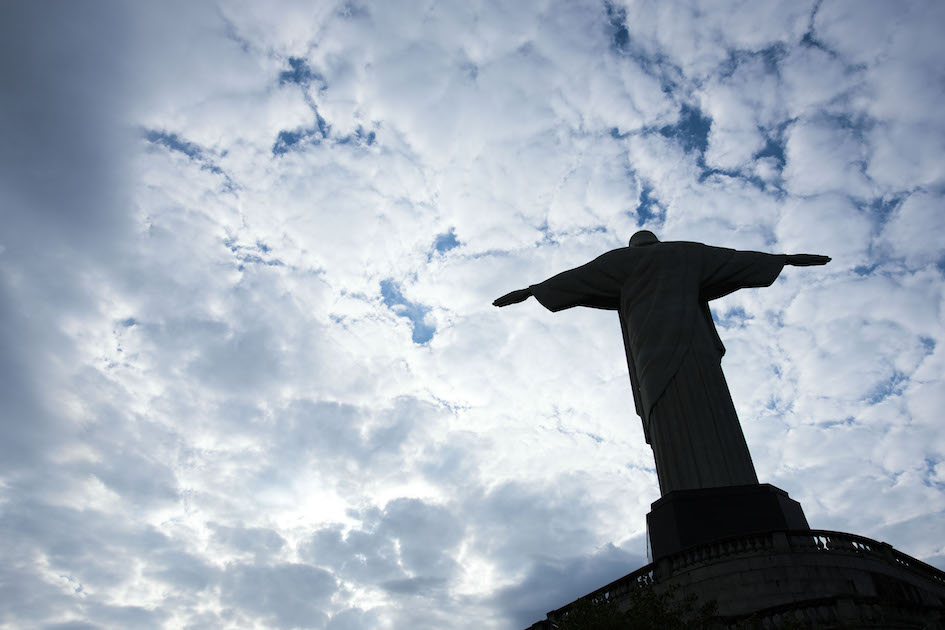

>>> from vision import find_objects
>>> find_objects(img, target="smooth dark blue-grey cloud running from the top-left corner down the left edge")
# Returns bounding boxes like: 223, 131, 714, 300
0, 2, 133, 478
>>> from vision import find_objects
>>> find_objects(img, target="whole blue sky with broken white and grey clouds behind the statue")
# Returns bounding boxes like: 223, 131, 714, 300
0, 0, 945, 630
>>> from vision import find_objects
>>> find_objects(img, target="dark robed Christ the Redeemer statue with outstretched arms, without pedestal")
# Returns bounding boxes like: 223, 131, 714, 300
493, 230, 830, 496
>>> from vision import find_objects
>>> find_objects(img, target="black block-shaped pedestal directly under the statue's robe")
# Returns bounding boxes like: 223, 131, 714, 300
646, 483, 810, 561
